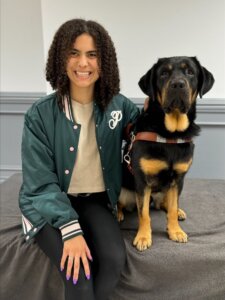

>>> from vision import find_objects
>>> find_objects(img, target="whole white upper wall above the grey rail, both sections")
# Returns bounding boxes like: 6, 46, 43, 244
0, 0, 225, 98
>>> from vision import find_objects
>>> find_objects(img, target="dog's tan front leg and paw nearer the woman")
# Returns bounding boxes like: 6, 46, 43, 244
133, 187, 152, 251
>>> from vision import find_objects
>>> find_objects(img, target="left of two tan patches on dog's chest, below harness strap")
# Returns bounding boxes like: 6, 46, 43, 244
140, 158, 169, 175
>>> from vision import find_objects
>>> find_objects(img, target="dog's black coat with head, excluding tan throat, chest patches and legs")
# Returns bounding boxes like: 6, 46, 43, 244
123, 56, 214, 214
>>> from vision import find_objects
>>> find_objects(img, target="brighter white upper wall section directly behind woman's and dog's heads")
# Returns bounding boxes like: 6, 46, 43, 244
41, 0, 225, 98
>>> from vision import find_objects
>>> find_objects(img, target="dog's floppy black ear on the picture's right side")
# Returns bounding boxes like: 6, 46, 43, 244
194, 57, 215, 98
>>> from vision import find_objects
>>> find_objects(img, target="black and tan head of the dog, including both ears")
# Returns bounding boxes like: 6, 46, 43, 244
139, 56, 214, 114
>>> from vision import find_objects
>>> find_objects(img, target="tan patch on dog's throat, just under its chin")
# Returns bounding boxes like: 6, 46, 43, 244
164, 110, 189, 132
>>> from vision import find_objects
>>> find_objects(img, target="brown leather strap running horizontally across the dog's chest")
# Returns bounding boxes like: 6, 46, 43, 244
133, 131, 192, 144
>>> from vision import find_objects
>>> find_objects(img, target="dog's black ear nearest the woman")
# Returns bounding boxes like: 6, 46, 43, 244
138, 65, 155, 101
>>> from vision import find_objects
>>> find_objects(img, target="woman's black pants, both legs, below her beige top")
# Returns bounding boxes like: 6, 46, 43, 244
36, 193, 126, 300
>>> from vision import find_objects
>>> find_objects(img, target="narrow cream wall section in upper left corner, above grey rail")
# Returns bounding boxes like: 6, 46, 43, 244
0, 0, 46, 92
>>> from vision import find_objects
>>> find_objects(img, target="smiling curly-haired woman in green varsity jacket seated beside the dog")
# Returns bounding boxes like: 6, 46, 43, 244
19, 19, 138, 300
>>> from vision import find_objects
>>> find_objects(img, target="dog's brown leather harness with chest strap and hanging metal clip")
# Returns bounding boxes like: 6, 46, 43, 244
123, 131, 192, 174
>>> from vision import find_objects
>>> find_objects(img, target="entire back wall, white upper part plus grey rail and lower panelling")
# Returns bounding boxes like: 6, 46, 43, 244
0, 0, 225, 181
